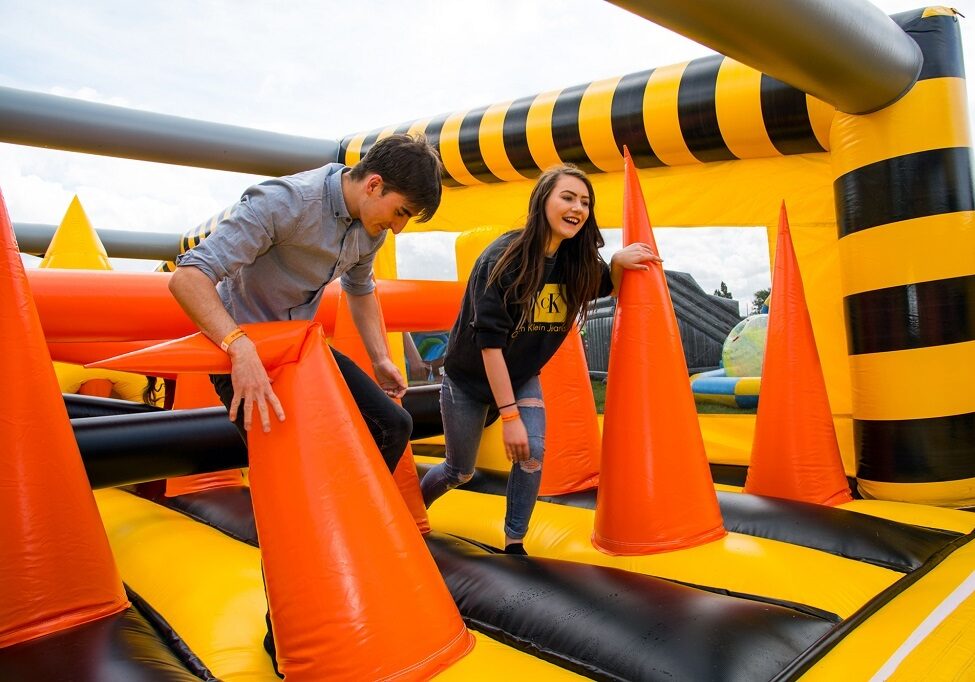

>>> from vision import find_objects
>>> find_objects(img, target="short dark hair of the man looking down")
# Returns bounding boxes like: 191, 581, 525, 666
349, 135, 443, 223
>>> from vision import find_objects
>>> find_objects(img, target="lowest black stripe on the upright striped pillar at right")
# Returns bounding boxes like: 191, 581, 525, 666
853, 412, 975, 483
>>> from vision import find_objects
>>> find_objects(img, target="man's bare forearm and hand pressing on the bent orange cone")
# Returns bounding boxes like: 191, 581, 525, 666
169, 266, 284, 432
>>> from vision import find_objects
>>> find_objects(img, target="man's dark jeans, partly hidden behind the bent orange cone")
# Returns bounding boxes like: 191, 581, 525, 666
210, 348, 413, 677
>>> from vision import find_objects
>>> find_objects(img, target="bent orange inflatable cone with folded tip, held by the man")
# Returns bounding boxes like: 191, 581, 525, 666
91, 322, 473, 682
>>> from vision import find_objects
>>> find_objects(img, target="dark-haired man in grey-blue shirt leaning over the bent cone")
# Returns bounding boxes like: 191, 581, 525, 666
169, 135, 441, 471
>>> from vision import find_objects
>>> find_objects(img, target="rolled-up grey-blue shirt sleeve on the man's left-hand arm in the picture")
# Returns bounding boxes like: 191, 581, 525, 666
176, 178, 301, 284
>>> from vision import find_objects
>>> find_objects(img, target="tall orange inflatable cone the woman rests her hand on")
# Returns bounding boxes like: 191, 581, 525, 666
592, 150, 726, 554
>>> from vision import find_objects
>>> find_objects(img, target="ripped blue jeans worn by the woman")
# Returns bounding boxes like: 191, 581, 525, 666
420, 376, 545, 540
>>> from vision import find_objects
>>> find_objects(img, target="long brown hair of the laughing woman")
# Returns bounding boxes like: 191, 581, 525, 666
488, 163, 605, 326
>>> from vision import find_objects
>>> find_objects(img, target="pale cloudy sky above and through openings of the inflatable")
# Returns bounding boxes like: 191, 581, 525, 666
0, 0, 975, 310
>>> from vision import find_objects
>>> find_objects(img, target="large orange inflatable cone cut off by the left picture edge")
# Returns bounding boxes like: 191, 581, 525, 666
0, 186, 128, 647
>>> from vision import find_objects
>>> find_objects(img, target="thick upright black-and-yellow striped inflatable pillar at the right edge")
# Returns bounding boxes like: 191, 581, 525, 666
830, 8, 975, 506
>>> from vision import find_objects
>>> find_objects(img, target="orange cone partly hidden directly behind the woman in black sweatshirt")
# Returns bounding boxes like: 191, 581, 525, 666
539, 326, 601, 495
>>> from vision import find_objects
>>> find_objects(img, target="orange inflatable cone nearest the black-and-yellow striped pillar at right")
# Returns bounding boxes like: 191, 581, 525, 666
745, 202, 851, 505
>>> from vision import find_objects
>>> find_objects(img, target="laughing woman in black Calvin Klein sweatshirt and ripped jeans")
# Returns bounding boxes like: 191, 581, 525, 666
420, 164, 660, 554
